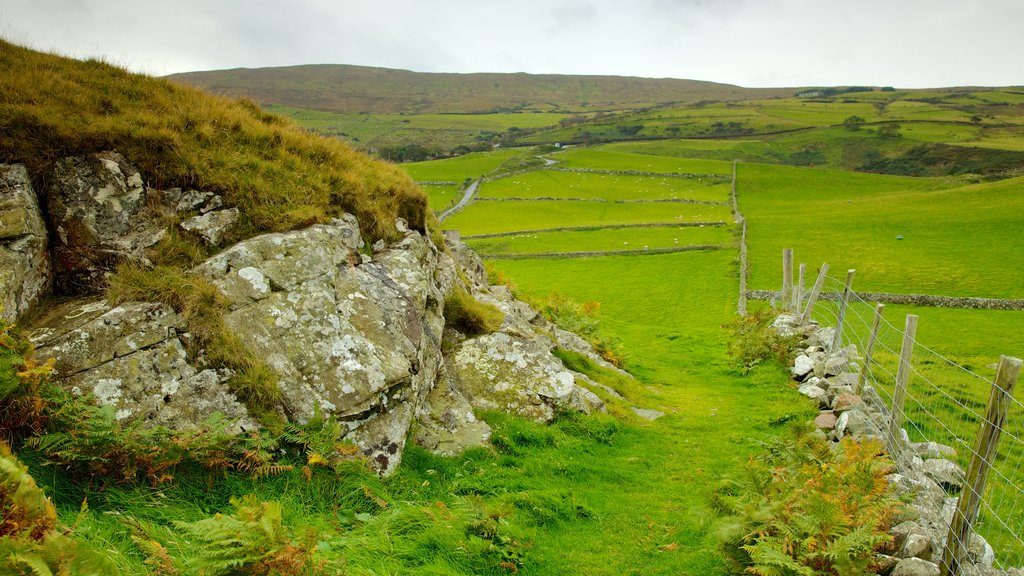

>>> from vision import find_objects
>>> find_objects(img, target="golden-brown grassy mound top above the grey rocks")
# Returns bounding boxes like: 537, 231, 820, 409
0, 40, 429, 238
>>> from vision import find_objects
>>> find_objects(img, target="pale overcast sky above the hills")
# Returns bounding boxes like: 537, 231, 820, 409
0, 0, 1024, 88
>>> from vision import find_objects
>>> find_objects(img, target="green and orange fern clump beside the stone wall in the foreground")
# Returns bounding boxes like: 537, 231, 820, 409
717, 431, 902, 576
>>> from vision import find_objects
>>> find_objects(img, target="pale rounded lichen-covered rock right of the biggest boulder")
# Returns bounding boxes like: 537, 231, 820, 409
450, 332, 603, 422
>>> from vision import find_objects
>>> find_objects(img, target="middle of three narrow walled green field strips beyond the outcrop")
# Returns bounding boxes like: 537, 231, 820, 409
444, 200, 731, 236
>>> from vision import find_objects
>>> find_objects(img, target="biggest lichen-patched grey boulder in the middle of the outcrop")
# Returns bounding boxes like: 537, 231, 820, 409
193, 215, 455, 474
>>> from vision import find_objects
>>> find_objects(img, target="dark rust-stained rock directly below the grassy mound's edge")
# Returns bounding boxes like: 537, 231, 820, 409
45, 152, 166, 294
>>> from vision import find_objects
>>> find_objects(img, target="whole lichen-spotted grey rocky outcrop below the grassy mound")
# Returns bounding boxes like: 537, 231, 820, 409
3, 153, 603, 474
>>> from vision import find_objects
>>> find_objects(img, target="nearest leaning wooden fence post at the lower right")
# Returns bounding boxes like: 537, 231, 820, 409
940, 356, 1021, 576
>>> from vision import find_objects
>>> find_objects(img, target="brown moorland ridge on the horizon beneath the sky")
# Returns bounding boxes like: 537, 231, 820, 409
168, 65, 797, 114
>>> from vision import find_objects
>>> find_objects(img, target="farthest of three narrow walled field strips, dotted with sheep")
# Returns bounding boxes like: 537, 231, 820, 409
478, 170, 729, 202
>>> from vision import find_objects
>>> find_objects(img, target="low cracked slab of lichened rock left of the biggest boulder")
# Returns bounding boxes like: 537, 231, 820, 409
30, 301, 257, 433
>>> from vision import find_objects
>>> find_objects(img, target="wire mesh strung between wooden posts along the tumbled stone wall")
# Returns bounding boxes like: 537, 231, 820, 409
797, 277, 1024, 570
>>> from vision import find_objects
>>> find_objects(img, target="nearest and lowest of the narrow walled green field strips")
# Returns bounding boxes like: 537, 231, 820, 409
465, 227, 732, 254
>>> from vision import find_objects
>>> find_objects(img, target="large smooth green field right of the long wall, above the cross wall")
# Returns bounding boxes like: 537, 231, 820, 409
738, 164, 1024, 298
